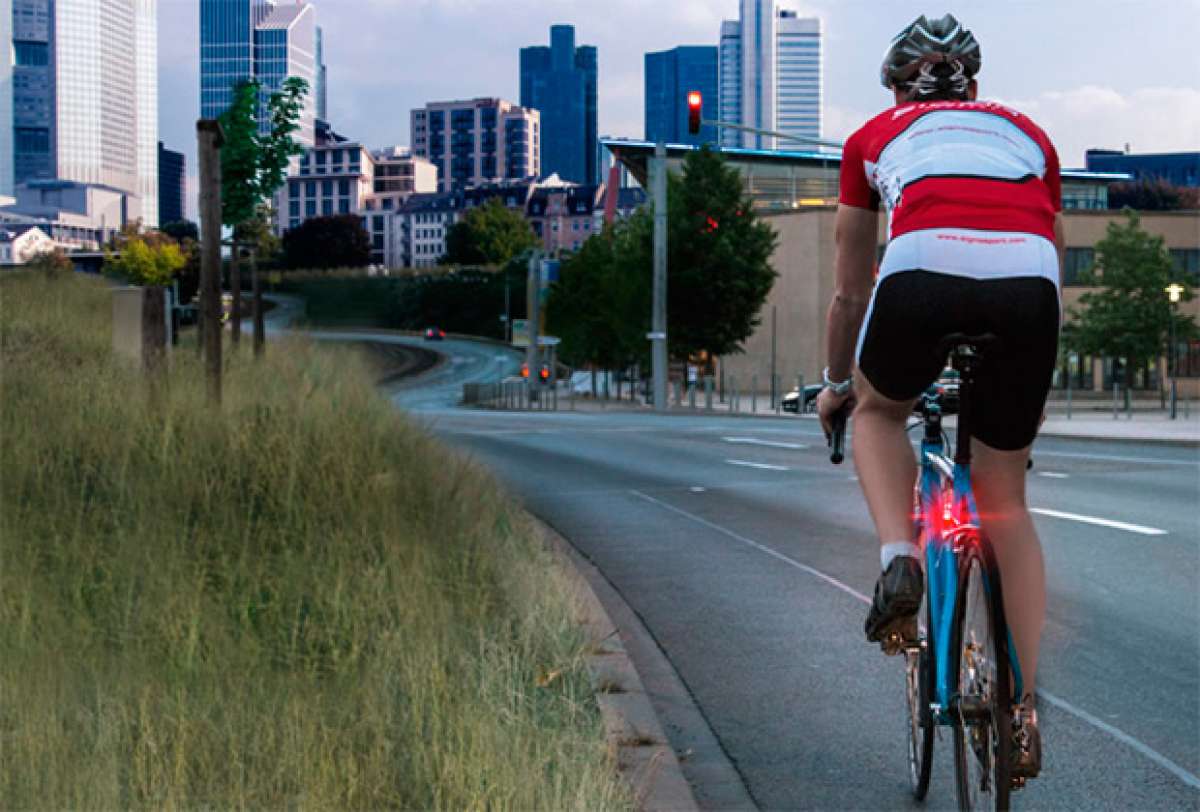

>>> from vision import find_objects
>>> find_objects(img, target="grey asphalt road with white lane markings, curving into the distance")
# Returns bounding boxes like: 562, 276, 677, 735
321, 326, 1200, 810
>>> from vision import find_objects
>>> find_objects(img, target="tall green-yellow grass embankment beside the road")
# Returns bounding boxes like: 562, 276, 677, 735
0, 275, 628, 810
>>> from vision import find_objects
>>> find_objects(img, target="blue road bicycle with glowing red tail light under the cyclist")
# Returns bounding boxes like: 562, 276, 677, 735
829, 333, 1024, 810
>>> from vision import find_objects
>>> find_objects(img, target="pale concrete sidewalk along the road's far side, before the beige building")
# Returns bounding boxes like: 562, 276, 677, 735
532, 393, 1200, 445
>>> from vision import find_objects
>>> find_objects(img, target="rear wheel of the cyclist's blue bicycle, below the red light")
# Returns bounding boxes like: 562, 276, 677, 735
949, 540, 1013, 812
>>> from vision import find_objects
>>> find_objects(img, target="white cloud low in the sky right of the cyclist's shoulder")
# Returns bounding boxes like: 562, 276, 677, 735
1009, 85, 1200, 167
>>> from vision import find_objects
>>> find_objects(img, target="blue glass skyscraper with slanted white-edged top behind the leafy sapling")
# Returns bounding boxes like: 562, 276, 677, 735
200, 0, 325, 145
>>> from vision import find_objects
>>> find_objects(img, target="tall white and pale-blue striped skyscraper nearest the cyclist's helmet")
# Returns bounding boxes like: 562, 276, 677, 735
719, 0, 822, 149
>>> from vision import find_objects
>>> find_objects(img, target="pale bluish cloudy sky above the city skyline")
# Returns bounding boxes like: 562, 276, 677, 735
158, 0, 1200, 216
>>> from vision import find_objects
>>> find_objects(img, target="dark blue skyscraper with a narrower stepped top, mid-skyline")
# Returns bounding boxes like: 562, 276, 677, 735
521, 25, 599, 185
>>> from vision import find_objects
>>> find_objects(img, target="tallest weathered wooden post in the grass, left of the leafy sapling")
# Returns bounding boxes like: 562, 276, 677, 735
196, 119, 224, 403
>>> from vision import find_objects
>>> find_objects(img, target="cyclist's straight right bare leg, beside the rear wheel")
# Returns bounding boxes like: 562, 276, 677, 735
971, 439, 1046, 699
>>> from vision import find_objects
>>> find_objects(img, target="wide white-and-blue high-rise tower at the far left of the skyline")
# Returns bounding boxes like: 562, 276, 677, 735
11, 0, 158, 225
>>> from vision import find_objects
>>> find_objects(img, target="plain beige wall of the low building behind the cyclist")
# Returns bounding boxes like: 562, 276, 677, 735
719, 206, 1200, 397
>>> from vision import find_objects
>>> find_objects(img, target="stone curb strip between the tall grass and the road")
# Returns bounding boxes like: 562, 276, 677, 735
537, 512, 700, 812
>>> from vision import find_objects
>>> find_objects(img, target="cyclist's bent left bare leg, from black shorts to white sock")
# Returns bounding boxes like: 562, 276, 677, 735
853, 371, 917, 545
